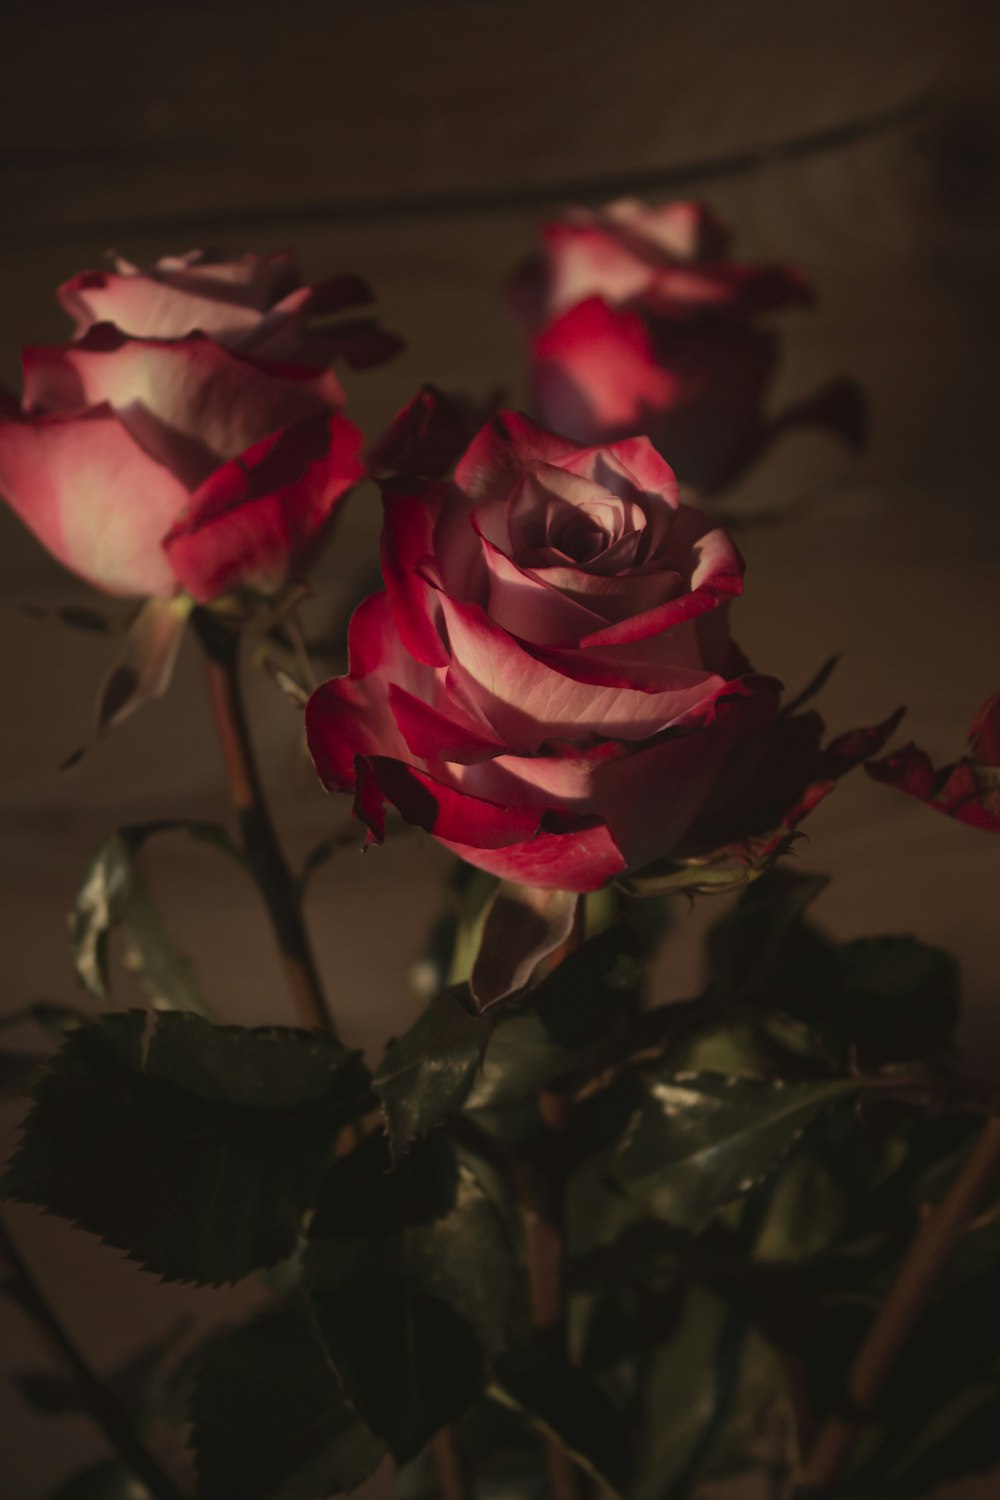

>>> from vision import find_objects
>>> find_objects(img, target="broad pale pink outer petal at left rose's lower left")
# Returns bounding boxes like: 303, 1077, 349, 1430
0, 405, 187, 596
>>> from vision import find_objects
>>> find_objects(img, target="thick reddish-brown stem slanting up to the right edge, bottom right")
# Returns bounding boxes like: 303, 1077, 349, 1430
796, 1116, 1000, 1500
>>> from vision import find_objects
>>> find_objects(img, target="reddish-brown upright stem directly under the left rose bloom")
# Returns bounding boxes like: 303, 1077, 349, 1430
193, 609, 339, 1041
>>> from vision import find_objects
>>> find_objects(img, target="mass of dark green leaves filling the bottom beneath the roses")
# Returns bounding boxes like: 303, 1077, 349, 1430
1, 876, 1000, 1500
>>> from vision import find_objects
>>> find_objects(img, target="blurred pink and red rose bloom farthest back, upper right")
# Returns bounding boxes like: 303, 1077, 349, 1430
511, 200, 864, 492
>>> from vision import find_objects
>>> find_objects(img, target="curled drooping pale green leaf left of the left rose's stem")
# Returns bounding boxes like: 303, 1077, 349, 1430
69, 819, 243, 1016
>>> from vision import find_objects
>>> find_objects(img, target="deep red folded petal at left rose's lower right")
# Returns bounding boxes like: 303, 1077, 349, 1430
163, 417, 364, 603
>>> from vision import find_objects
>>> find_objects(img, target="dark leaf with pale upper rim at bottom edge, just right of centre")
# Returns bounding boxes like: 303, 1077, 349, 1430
489, 1350, 634, 1496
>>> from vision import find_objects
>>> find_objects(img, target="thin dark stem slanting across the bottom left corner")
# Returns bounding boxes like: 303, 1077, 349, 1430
0, 1218, 181, 1500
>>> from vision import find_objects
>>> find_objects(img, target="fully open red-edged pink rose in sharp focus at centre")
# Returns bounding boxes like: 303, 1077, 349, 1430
306, 413, 778, 891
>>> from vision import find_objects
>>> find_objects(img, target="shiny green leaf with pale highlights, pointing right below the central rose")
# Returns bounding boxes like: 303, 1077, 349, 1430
583, 1073, 858, 1232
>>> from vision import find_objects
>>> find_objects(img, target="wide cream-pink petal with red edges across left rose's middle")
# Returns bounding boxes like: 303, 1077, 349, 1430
24, 324, 343, 489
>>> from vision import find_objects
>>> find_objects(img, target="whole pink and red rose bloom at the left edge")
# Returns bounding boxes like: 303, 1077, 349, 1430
0, 252, 399, 600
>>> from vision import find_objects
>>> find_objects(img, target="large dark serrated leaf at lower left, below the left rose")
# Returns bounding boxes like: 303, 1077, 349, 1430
0, 1011, 372, 1283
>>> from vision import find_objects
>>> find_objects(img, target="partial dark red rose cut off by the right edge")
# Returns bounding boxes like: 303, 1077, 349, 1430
865, 693, 1000, 834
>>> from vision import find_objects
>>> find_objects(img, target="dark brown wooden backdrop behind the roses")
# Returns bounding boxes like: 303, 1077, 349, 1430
0, 0, 1000, 1500
